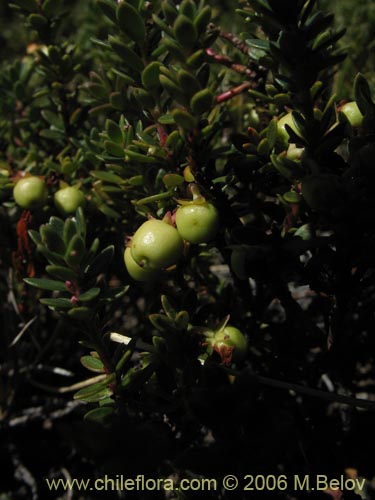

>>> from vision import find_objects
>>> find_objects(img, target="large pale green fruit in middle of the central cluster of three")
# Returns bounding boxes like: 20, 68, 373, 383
131, 219, 184, 269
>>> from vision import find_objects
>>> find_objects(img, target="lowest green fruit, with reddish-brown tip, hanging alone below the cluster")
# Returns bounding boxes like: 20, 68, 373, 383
211, 325, 247, 364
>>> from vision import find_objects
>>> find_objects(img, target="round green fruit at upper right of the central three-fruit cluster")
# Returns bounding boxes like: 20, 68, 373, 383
176, 203, 219, 244
